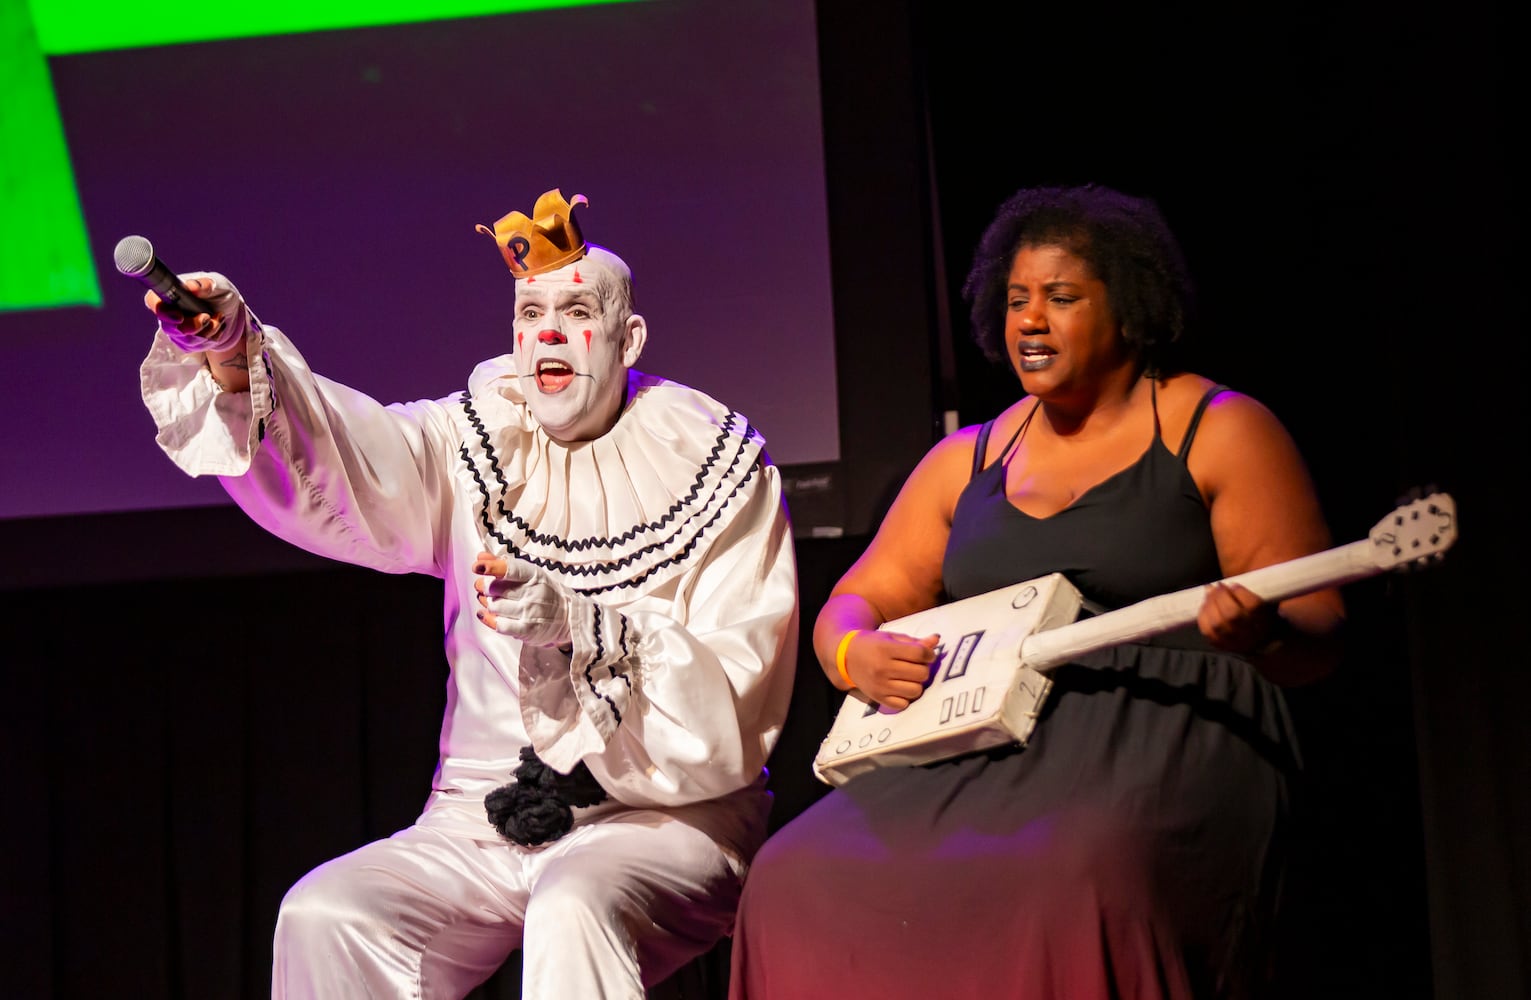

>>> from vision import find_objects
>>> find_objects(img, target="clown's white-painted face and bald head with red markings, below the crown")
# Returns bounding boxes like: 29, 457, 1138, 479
514, 247, 646, 444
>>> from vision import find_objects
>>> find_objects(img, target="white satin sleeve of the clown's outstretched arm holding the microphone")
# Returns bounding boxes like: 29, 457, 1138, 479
139, 273, 453, 576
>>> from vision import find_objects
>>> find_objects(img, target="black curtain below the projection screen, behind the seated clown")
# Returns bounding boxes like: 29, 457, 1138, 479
0, 529, 859, 998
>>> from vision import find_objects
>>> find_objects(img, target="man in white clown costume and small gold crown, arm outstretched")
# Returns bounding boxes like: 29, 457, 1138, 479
141, 190, 798, 1000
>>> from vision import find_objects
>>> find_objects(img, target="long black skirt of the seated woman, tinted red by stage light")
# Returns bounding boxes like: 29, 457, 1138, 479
730, 645, 1300, 1000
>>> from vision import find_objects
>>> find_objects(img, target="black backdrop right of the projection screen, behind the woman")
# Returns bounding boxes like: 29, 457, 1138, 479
900, 0, 1531, 1000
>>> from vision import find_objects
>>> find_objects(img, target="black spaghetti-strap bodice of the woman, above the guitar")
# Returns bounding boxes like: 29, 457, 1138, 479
942, 379, 1228, 608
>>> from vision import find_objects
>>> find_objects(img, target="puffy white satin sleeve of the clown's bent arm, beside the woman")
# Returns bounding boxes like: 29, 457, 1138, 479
521, 459, 799, 806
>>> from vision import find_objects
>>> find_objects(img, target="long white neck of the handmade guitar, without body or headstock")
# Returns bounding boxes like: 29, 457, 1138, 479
1021, 539, 1382, 671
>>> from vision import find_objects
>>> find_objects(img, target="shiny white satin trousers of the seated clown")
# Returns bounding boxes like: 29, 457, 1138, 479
271, 810, 743, 1000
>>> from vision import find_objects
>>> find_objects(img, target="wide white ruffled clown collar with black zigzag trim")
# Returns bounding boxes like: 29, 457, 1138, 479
461, 355, 766, 596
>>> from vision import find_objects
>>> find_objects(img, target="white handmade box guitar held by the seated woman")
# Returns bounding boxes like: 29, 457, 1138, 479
813, 493, 1456, 786
